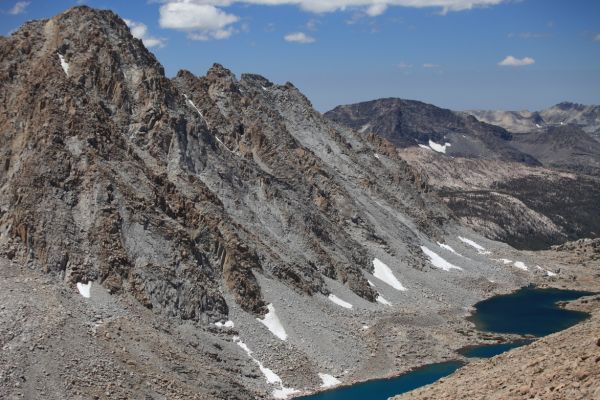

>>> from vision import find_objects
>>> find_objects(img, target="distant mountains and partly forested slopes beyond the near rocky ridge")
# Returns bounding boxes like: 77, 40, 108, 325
325, 99, 600, 249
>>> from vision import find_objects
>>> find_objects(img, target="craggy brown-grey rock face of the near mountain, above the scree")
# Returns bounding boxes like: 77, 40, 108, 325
0, 7, 448, 321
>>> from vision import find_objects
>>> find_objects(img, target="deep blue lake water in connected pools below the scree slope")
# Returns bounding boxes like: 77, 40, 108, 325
298, 287, 591, 400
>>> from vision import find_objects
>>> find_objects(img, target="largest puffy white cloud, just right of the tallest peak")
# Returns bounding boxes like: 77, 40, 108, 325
159, 0, 240, 40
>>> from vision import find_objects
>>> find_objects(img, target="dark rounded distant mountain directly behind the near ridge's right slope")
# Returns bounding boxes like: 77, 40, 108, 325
325, 98, 539, 165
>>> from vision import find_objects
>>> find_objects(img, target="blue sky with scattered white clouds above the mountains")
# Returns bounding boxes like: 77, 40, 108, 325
0, 0, 600, 111
